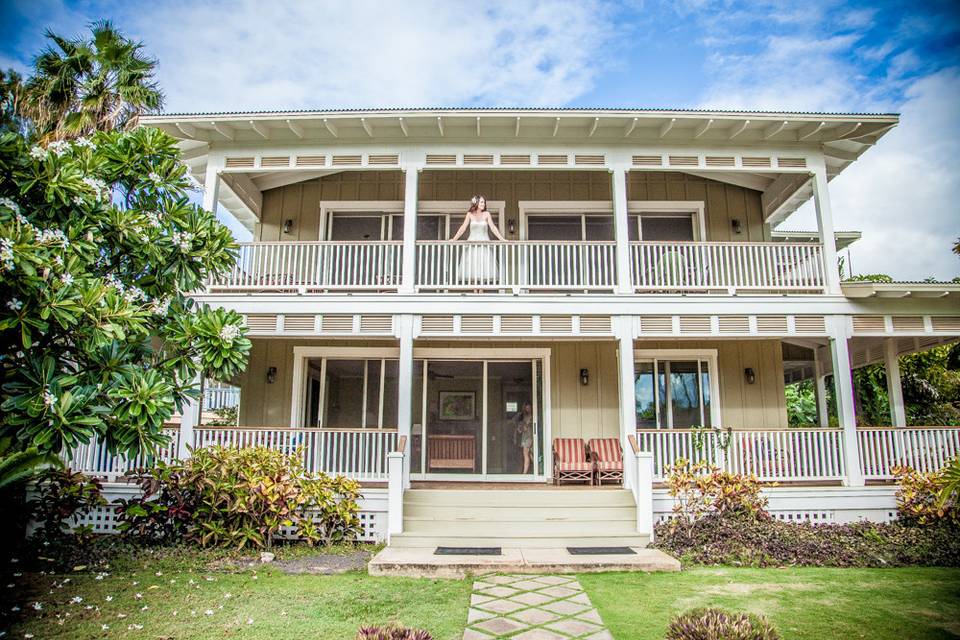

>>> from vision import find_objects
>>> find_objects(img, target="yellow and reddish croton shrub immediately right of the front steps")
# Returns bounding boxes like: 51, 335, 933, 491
666, 458, 769, 521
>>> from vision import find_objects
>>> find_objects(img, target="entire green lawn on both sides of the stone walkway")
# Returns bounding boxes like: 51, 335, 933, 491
7, 548, 960, 640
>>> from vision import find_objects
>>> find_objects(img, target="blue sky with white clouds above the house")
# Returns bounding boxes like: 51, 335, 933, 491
0, 0, 960, 278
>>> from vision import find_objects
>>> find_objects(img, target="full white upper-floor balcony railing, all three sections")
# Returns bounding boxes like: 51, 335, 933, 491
207, 240, 826, 295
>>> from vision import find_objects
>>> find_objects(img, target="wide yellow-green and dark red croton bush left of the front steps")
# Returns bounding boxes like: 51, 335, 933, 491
118, 446, 360, 549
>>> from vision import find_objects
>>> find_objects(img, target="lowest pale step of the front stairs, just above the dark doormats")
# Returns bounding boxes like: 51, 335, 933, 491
390, 532, 650, 549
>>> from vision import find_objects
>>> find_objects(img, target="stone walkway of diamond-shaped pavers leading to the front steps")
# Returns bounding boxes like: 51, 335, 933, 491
463, 575, 613, 640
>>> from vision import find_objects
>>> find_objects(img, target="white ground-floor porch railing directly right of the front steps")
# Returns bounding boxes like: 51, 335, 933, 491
637, 429, 845, 482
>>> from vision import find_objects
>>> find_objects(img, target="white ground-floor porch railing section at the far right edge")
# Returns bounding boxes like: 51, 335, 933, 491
857, 427, 960, 480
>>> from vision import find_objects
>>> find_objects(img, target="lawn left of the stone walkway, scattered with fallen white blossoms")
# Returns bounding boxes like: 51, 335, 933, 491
0, 547, 471, 640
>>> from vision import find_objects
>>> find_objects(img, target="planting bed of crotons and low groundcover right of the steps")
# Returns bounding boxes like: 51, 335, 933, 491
655, 460, 960, 567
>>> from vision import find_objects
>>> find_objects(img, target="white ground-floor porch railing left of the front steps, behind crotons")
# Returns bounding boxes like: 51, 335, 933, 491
193, 427, 397, 481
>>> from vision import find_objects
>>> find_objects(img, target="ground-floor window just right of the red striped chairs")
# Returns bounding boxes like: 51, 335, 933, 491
634, 356, 716, 429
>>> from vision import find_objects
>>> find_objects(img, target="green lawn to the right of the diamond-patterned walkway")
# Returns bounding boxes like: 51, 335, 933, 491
580, 567, 960, 640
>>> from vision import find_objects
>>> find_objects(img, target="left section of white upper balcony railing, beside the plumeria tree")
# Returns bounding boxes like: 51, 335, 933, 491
207, 241, 403, 292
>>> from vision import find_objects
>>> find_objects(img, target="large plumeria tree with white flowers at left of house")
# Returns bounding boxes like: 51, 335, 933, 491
0, 128, 250, 455
